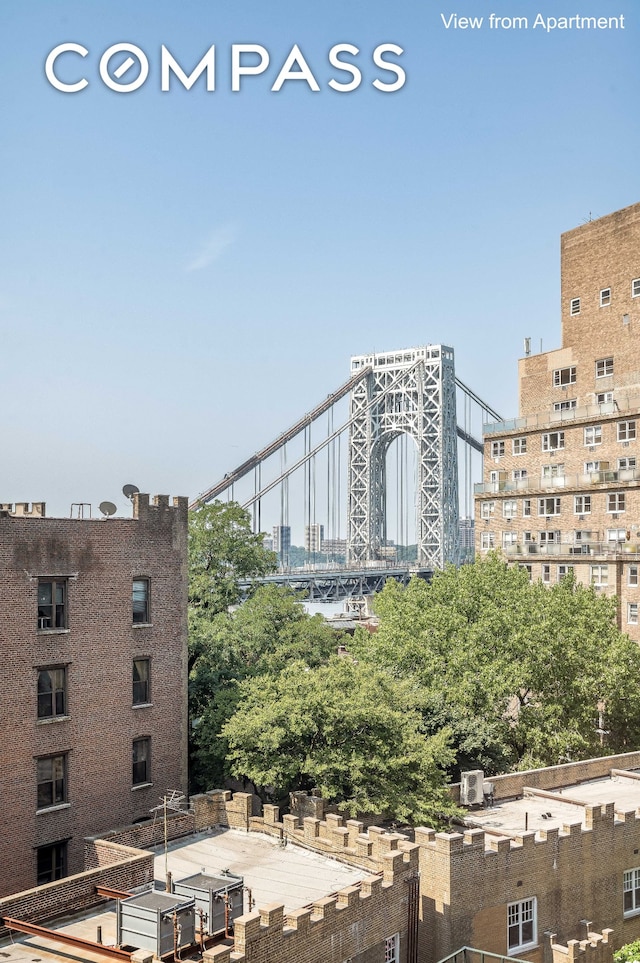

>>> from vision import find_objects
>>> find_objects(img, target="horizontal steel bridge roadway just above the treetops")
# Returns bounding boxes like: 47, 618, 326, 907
240, 562, 433, 602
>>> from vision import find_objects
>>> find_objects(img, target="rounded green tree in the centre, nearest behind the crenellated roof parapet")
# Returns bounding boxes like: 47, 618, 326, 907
223, 655, 456, 823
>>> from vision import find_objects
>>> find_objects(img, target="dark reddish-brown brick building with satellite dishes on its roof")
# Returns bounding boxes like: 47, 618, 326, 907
0, 494, 187, 895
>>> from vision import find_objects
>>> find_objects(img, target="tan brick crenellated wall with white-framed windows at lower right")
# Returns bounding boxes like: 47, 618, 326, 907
416, 803, 640, 963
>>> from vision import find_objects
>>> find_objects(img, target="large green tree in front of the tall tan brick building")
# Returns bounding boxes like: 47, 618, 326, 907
354, 555, 640, 774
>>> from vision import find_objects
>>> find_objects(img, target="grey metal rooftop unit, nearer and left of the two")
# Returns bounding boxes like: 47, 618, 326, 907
117, 889, 196, 958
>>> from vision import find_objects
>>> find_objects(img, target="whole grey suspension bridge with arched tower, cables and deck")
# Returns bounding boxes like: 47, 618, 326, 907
190, 345, 501, 600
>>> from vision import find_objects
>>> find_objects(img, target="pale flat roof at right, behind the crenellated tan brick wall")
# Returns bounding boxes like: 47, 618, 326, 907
465, 770, 640, 836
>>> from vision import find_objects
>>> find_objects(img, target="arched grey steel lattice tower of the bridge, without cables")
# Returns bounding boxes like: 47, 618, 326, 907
347, 344, 459, 568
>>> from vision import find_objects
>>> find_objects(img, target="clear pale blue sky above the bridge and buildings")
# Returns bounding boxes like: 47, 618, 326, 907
0, 0, 640, 528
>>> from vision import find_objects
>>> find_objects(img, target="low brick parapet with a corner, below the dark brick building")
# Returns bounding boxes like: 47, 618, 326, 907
0, 840, 153, 939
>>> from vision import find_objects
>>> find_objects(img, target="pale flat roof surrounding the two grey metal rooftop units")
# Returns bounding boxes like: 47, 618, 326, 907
0, 829, 370, 963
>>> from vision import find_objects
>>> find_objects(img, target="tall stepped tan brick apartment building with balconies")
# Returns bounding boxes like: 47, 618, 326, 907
476, 204, 640, 641
